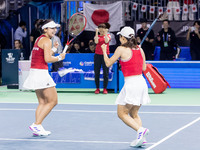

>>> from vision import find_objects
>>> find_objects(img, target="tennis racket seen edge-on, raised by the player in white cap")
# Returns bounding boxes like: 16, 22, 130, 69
140, 11, 168, 46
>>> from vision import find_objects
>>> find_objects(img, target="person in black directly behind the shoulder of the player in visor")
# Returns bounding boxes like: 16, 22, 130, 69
30, 19, 41, 47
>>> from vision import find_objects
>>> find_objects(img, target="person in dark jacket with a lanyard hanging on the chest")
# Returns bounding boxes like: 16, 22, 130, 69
157, 20, 176, 60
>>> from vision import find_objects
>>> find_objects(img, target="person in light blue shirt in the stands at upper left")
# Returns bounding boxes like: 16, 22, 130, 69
14, 21, 27, 43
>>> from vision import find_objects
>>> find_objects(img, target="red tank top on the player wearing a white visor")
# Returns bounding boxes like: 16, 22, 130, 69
31, 35, 48, 69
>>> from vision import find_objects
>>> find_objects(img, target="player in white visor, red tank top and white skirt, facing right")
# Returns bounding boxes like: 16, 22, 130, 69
23, 19, 65, 136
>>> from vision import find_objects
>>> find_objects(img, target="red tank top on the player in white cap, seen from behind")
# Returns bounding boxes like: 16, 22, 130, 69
119, 46, 143, 77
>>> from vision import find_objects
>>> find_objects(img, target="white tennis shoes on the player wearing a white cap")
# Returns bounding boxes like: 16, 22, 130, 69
130, 127, 149, 147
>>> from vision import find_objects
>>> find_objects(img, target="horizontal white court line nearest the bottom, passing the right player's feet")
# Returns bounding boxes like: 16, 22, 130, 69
0, 138, 154, 145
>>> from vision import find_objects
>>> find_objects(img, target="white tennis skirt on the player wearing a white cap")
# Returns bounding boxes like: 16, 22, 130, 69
115, 75, 151, 106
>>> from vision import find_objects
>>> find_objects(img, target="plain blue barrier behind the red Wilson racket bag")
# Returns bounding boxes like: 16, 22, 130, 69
119, 61, 200, 91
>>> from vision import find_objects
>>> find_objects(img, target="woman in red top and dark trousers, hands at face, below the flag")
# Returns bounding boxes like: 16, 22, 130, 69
94, 23, 111, 94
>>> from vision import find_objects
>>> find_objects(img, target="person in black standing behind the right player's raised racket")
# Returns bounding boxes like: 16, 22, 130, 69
137, 19, 154, 60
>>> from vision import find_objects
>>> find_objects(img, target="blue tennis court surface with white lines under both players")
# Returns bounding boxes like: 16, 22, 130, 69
0, 103, 200, 150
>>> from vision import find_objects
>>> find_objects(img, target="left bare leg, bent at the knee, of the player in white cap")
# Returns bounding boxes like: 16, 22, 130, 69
117, 104, 141, 131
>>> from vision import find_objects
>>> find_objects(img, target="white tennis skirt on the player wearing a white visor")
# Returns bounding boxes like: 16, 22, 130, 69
23, 69, 56, 90
